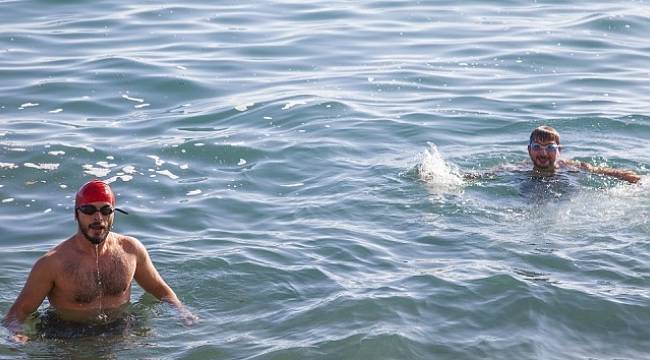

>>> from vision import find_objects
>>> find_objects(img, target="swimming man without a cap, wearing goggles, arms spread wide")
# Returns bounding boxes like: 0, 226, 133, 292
463, 126, 641, 183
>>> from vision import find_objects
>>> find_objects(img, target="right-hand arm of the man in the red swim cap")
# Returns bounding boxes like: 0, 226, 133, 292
133, 239, 197, 325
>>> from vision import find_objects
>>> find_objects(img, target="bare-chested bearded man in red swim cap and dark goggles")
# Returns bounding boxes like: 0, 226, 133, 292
3, 180, 198, 342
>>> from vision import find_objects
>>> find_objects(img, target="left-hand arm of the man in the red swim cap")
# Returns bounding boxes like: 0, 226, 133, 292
2, 255, 56, 342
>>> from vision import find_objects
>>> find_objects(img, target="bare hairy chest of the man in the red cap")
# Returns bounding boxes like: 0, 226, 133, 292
57, 252, 135, 304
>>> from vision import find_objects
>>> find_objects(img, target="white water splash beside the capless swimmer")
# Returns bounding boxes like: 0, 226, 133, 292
416, 143, 464, 189
